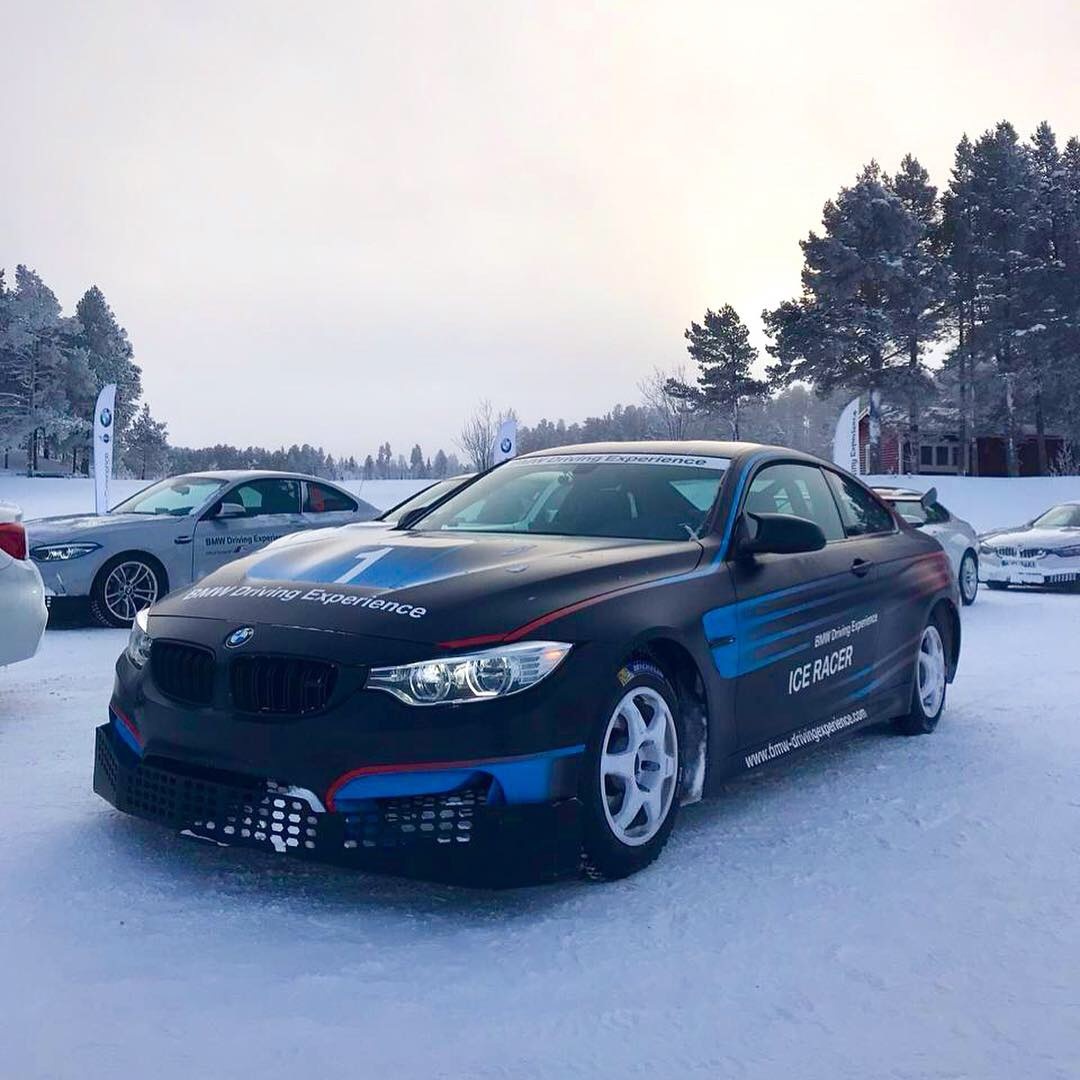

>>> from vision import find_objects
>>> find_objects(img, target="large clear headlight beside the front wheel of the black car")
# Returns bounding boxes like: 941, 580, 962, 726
366, 642, 570, 705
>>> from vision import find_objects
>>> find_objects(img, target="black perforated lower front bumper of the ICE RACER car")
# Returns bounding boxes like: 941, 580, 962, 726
94, 720, 581, 887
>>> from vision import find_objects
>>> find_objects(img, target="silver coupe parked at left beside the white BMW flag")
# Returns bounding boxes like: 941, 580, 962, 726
26, 471, 378, 626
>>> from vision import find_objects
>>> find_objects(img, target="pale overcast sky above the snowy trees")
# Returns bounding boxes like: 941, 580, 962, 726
0, 0, 1080, 457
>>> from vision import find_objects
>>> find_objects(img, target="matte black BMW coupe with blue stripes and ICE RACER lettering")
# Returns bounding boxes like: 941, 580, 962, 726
94, 442, 960, 883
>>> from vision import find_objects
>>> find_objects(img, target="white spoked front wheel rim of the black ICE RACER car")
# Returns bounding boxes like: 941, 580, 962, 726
599, 687, 678, 848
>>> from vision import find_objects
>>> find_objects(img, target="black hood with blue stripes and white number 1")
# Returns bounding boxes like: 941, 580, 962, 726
150, 526, 702, 643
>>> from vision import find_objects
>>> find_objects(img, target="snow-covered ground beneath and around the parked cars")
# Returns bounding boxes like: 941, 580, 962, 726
0, 592, 1080, 1080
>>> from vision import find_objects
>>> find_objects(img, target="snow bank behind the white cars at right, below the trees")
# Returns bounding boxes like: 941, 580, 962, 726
864, 476, 1080, 532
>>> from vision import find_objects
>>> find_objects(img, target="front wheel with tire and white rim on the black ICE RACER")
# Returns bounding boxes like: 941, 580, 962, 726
579, 664, 683, 880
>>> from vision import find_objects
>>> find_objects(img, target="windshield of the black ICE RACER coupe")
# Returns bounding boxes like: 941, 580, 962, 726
417, 454, 729, 540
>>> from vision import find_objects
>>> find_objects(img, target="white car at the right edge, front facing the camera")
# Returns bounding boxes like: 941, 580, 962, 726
978, 502, 1080, 589
